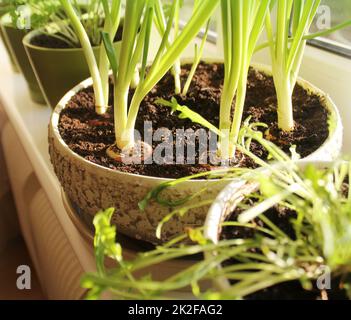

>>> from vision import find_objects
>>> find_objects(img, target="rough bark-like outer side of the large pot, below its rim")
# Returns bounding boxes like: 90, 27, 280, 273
49, 129, 224, 244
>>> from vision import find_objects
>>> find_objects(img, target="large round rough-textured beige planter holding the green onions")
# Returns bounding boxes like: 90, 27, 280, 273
49, 59, 342, 243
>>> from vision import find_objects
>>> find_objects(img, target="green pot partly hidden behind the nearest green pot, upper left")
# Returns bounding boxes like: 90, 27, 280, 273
0, 14, 45, 104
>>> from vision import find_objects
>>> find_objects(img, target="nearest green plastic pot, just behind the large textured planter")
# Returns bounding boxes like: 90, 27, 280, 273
23, 29, 120, 108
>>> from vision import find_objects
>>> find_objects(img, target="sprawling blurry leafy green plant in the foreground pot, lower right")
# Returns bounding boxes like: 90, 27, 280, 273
82, 125, 351, 299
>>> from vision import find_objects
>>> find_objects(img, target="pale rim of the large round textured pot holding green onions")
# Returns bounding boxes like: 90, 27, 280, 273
49, 58, 343, 184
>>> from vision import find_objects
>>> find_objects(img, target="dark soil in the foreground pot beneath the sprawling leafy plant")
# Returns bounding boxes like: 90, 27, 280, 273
221, 191, 351, 300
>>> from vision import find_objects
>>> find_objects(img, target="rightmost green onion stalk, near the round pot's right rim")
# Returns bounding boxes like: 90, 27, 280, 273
266, 0, 321, 132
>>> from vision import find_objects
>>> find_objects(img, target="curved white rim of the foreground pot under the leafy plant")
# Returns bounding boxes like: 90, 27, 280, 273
204, 160, 333, 290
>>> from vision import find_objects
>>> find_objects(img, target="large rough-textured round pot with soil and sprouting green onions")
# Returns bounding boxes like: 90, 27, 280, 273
49, 0, 350, 242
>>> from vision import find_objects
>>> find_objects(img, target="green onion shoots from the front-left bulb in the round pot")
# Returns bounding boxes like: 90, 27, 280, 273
99, 0, 217, 155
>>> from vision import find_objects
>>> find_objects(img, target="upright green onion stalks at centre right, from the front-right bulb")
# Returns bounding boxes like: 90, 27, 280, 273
219, 0, 270, 160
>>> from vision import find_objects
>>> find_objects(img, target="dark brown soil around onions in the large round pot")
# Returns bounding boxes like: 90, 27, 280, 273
59, 63, 329, 178
